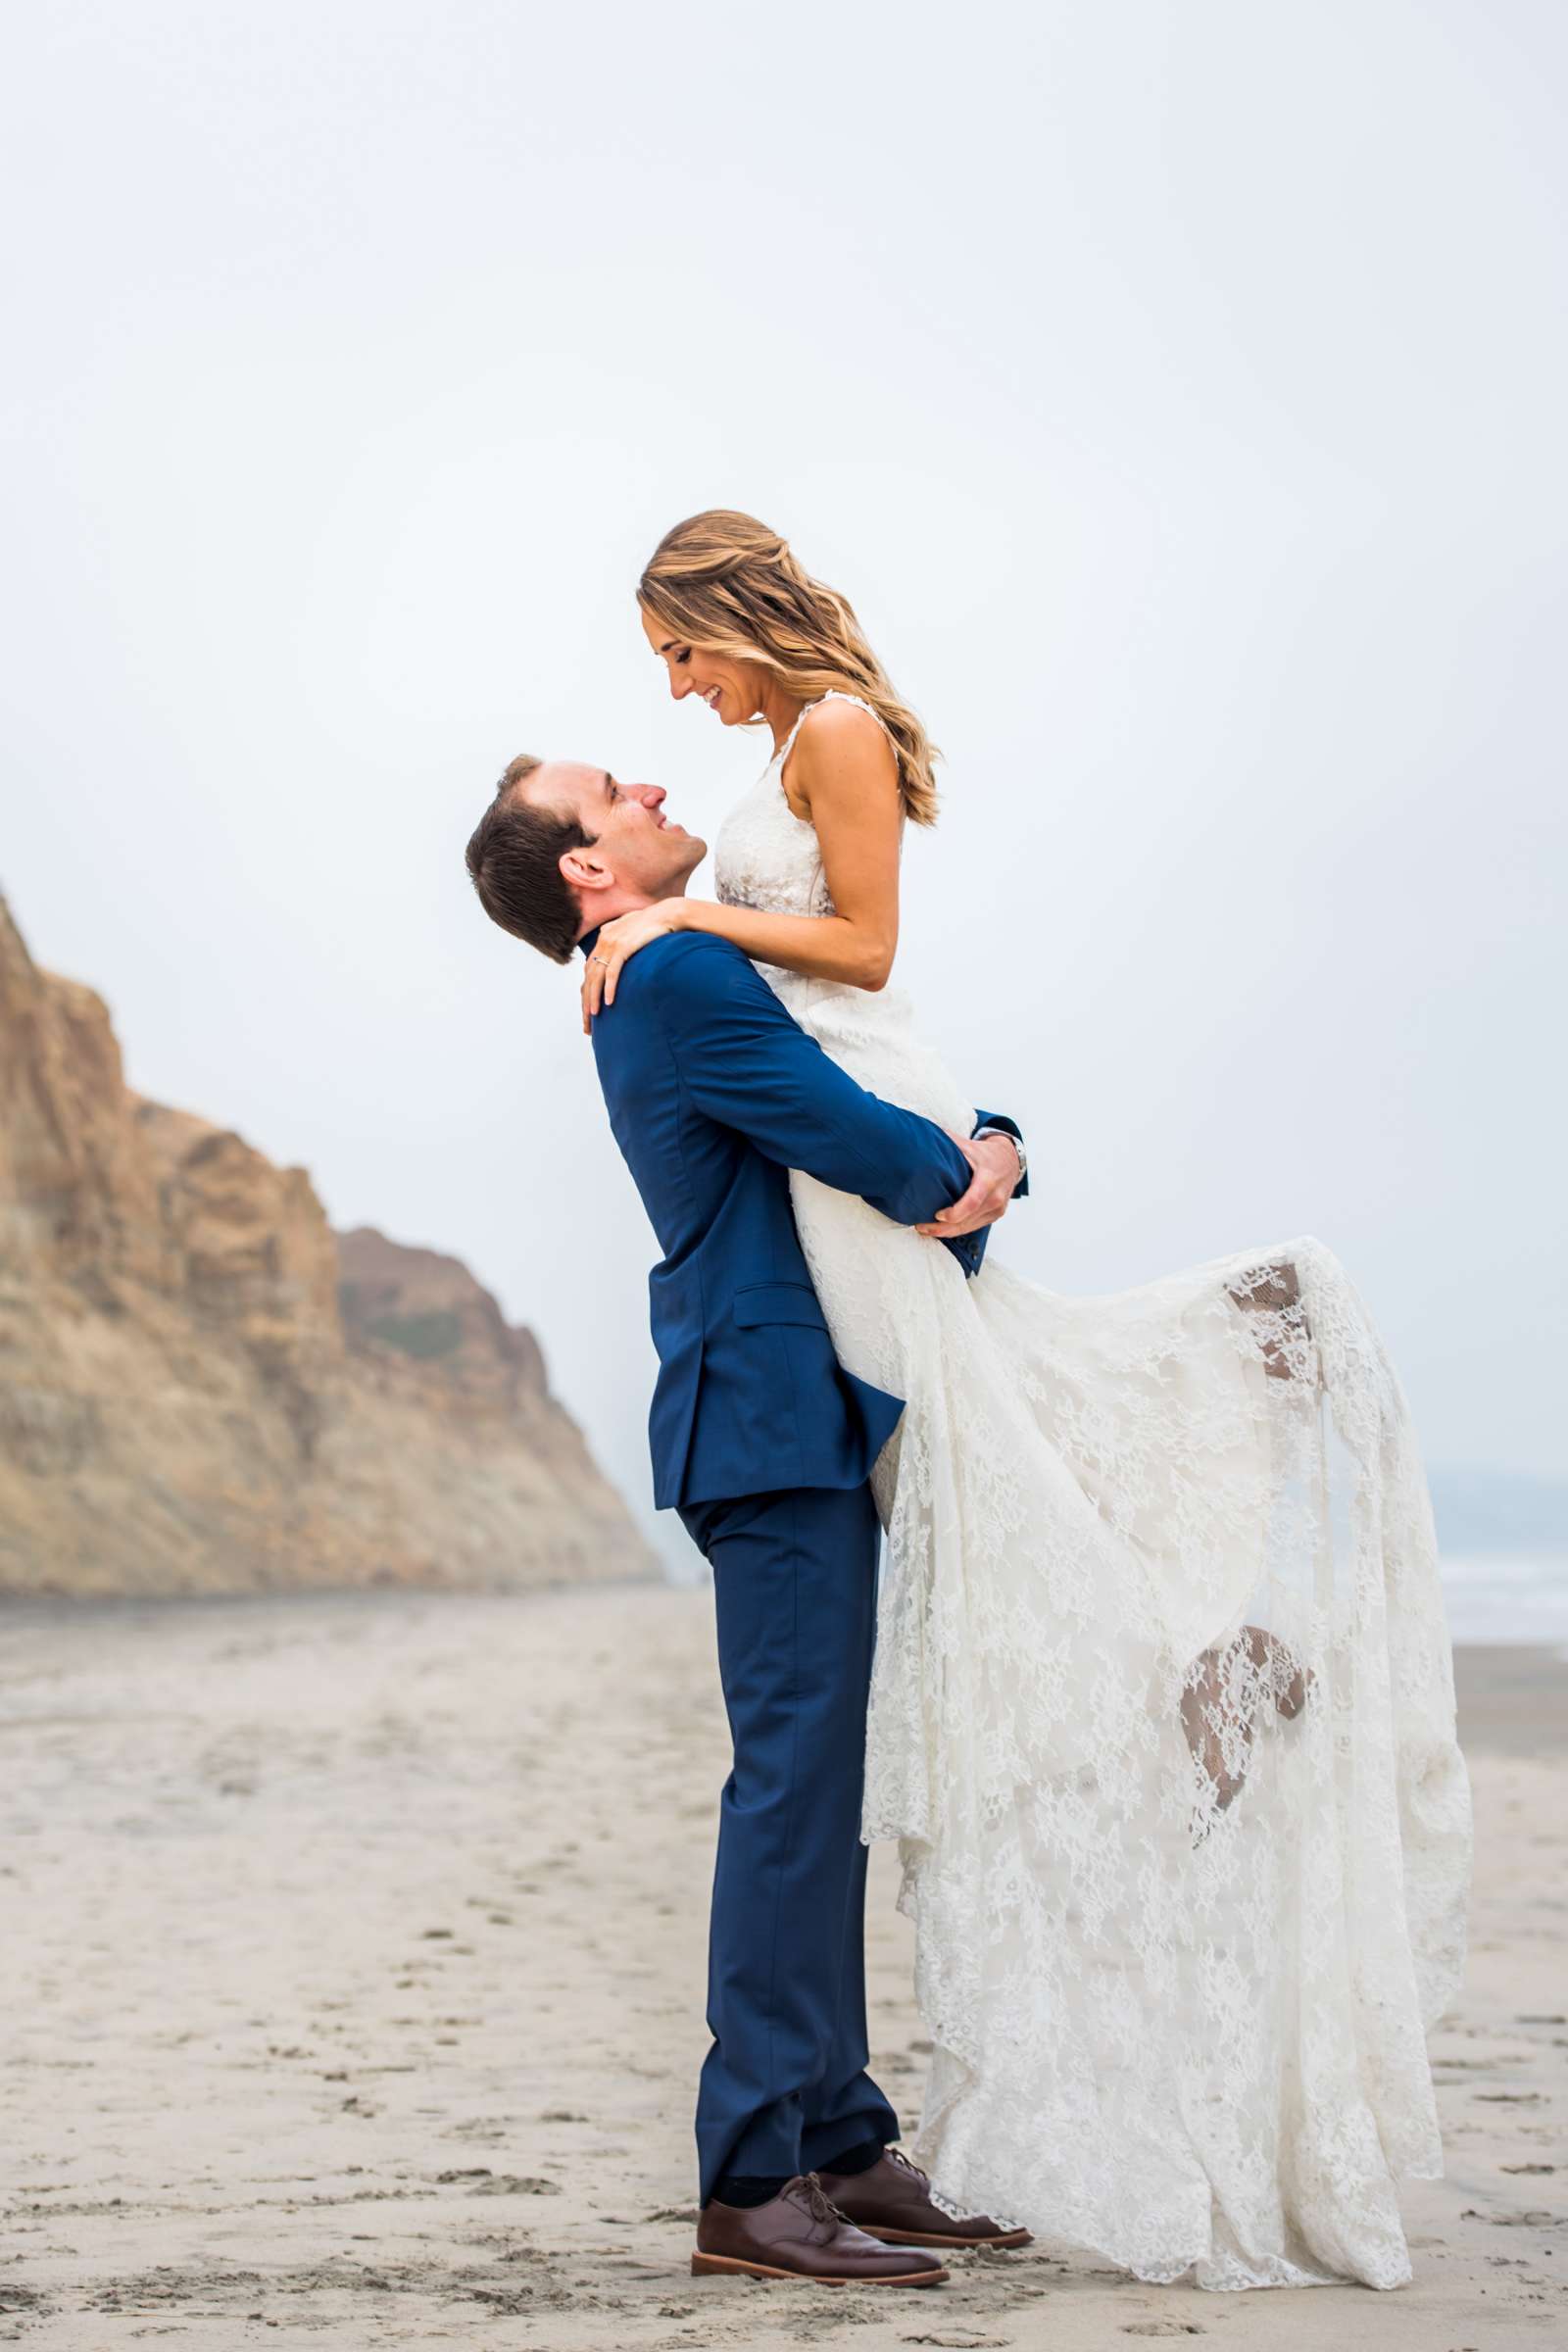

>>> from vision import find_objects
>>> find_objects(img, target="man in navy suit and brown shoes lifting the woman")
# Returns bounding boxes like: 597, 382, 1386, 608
467, 758, 1025, 2286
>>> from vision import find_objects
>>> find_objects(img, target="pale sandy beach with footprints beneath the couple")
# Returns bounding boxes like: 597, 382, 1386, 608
0, 1586, 1568, 2352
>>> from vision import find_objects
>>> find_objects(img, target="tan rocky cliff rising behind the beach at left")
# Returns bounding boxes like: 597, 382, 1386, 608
0, 901, 651, 1594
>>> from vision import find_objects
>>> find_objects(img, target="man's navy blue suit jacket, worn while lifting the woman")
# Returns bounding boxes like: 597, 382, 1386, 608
583, 931, 1022, 1510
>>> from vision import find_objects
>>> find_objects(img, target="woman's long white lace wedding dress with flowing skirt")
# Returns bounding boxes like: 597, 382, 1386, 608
714, 696, 1469, 2288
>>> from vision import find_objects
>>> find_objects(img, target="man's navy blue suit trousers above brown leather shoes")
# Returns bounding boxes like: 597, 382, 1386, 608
682, 1487, 898, 2199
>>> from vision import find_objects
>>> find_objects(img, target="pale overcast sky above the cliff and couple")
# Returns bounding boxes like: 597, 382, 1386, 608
0, 0, 1568, 1580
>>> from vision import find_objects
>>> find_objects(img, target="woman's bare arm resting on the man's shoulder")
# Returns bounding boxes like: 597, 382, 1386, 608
583, 704, 901, 1025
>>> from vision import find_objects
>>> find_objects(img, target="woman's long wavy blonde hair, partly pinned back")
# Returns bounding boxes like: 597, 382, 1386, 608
637, 506, 941, 825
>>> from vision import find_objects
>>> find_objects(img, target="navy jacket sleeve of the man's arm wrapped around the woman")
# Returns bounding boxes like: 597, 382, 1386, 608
653, 934, 968, 1225
